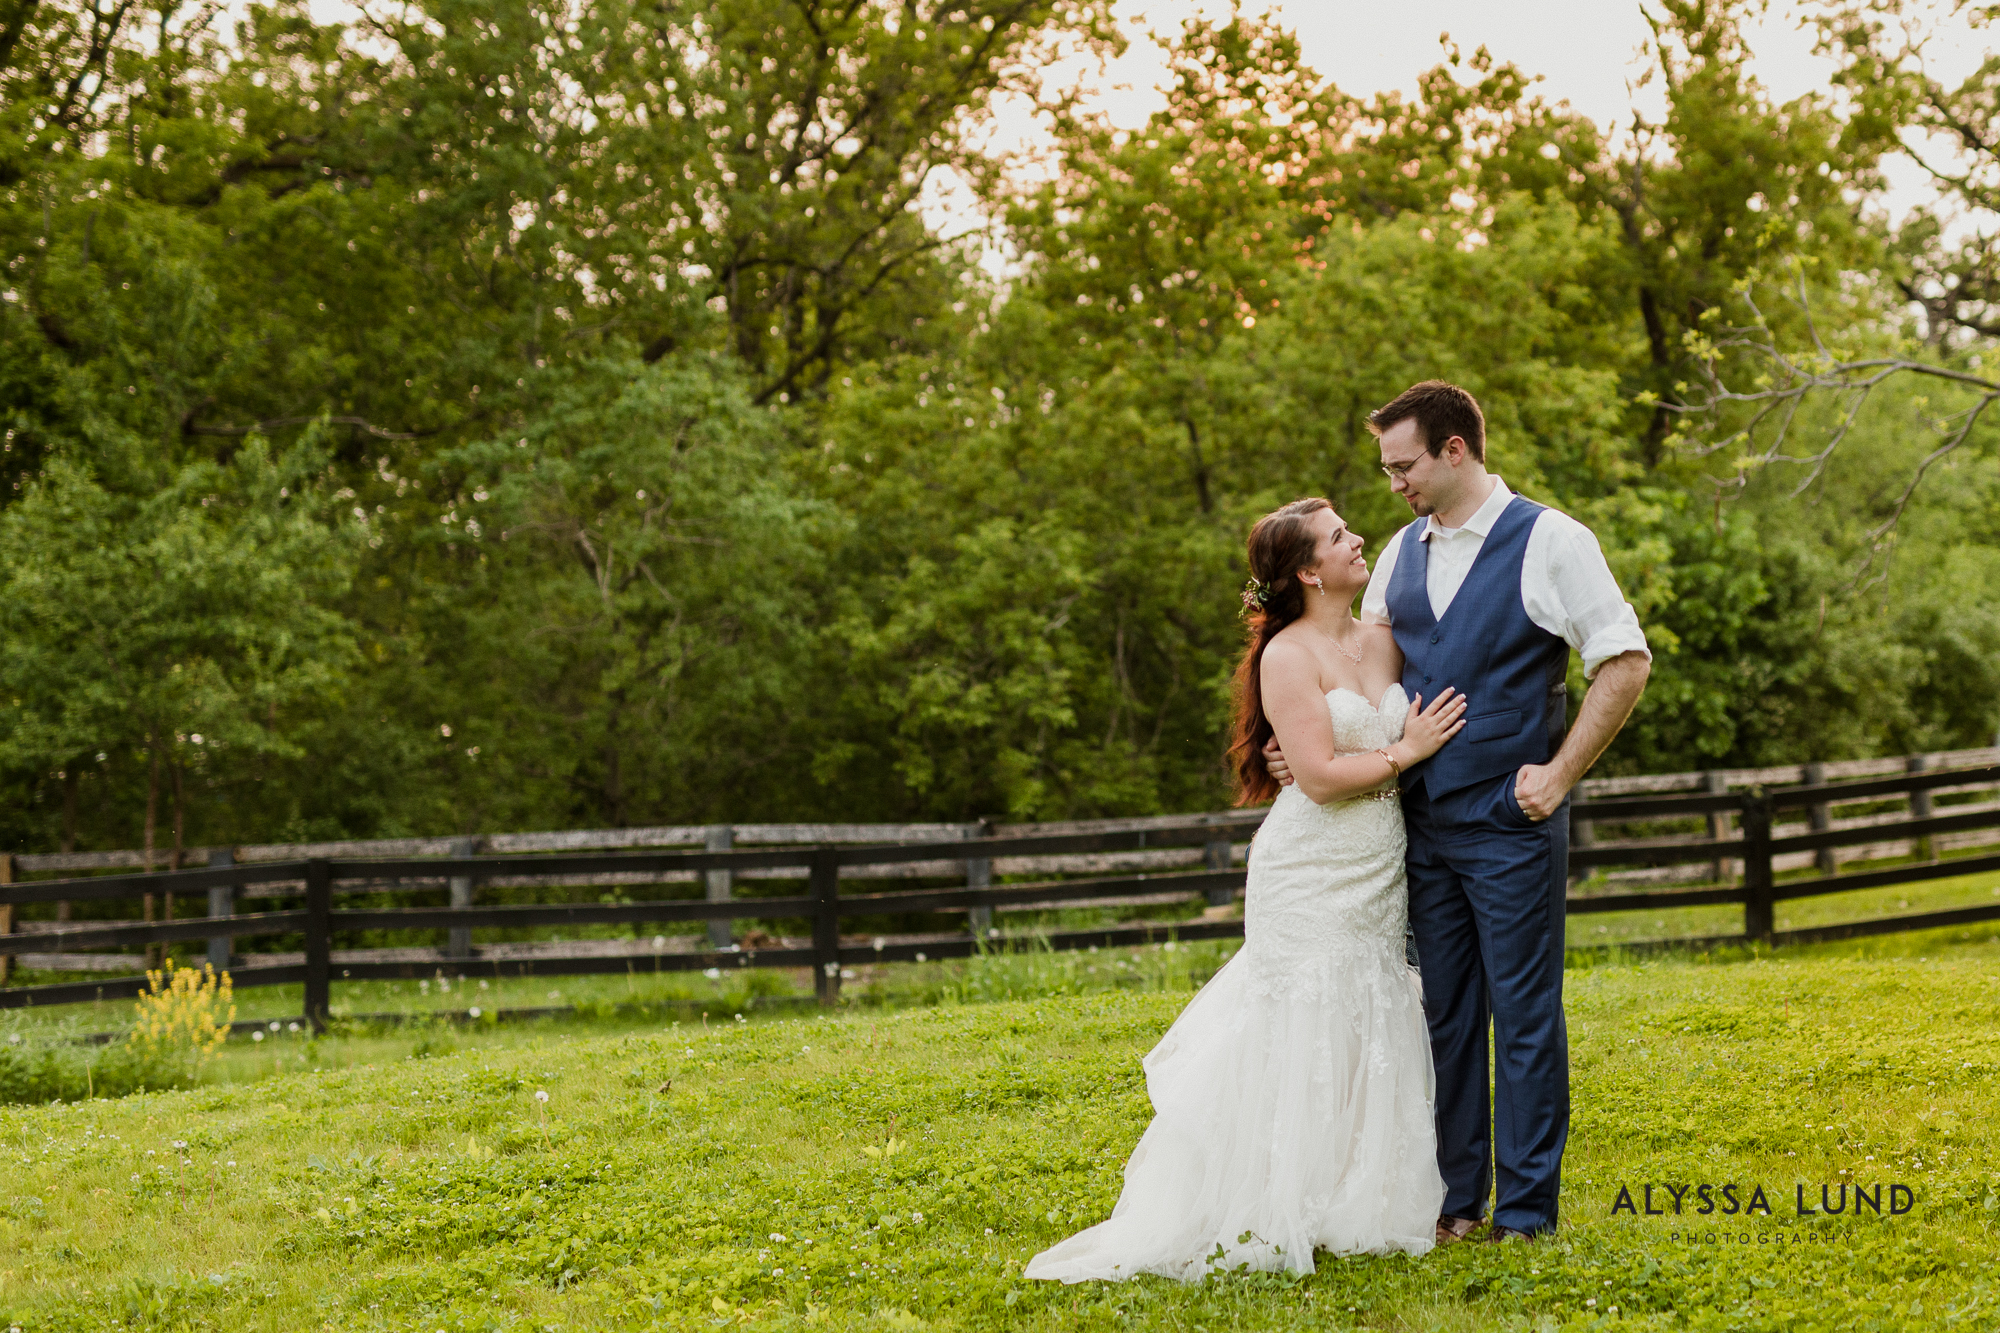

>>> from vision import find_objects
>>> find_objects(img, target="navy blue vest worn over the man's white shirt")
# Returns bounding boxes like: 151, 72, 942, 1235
1388, 496, 1570, 799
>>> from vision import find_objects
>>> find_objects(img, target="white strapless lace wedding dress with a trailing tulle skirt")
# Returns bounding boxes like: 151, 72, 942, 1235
1026, 685, 1444, 1283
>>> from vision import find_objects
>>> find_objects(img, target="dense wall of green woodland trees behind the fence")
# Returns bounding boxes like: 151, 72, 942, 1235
0, 0, 2000, 852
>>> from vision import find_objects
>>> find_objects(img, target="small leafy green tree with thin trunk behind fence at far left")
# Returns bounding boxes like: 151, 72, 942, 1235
0, 438, 352, 861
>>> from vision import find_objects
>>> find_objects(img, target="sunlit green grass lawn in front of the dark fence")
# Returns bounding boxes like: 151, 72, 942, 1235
0, 912, 2000, 1333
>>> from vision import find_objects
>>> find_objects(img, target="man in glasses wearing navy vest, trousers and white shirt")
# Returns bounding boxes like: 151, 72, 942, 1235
1266, 380, 1652, 1243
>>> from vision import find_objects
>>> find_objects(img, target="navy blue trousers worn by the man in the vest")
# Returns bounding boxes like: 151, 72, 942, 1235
1402, 773, 1570, 1233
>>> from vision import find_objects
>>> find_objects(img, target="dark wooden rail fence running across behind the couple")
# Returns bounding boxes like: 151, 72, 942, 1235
0, 765, 2000, 1025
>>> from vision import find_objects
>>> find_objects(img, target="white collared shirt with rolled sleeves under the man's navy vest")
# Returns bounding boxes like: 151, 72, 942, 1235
1362, 476, 1652, 677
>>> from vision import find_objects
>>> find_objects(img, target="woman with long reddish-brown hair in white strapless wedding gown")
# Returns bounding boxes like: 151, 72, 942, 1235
1026, 498, 1466, 1283
